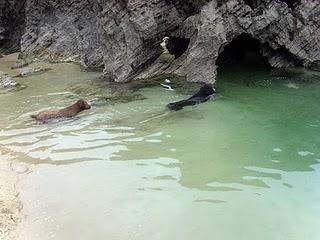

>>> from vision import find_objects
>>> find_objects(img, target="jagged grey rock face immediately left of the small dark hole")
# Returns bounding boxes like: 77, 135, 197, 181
99, 0, 185, 81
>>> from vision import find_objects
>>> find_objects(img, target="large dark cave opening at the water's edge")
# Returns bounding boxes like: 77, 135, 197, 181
216, 34, 270, 72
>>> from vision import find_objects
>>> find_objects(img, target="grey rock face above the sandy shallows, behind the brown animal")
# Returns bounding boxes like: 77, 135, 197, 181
21, 0, 103, 67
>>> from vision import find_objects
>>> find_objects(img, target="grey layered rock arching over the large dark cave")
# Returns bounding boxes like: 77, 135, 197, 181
151, 0, 320, 82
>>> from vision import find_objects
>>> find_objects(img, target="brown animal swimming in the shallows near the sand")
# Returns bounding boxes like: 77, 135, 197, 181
31, 99, 91, 121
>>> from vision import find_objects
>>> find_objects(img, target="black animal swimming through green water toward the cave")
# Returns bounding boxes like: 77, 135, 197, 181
167, 84, 216, 111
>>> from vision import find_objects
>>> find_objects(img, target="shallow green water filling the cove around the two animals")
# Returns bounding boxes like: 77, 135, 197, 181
0, 56, 320, 240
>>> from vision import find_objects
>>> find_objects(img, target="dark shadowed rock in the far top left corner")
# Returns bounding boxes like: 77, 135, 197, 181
0, 0, 25, 53
